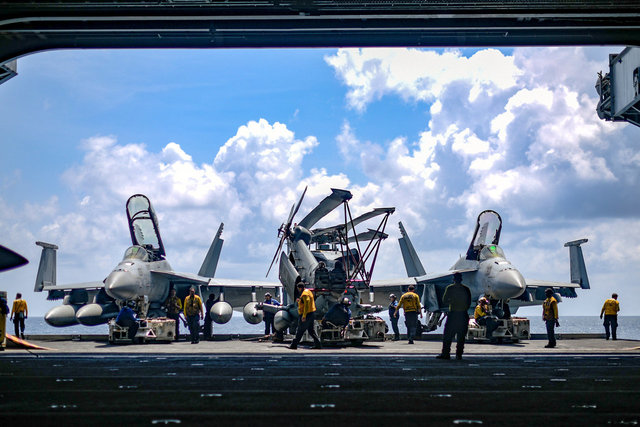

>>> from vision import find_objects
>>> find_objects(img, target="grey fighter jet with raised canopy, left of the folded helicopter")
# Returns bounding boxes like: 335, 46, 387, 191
34, 194, 281, 326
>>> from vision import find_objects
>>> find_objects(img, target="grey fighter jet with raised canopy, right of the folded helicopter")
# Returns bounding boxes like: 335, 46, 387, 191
371, 210, 590, 331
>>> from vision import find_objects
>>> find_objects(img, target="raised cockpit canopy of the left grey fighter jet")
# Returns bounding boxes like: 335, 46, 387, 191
127, 194, 165, 260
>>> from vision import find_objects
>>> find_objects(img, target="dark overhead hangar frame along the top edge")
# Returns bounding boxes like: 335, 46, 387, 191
0, 0, 640, 65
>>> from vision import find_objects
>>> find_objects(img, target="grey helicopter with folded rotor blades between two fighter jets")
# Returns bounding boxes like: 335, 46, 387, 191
260, 188, 395, 342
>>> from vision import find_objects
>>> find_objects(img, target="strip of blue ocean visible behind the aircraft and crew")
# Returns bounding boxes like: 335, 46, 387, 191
13, 312, 640, 340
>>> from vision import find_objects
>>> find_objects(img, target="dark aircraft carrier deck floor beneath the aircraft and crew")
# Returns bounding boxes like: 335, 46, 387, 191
0, 336, 640, 426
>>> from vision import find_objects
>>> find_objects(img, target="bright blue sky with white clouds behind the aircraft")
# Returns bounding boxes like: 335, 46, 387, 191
0, 47, 640, 316
